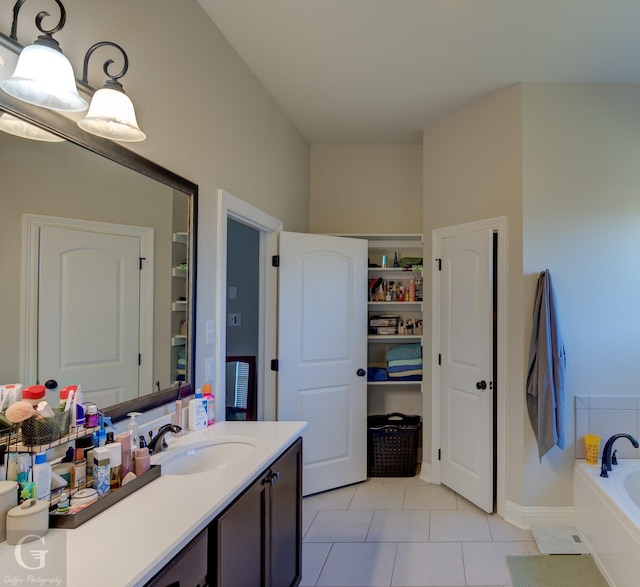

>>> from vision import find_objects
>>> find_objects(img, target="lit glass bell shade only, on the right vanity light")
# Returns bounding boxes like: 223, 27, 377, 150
78, 88, 147, 142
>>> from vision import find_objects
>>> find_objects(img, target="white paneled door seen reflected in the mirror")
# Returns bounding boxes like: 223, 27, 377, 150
38, 226, 140, 406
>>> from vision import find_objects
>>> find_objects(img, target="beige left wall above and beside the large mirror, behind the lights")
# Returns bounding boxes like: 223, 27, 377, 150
3, 0, 309, 390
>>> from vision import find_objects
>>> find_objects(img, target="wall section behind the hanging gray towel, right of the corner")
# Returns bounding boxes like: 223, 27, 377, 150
521, 84, 640, 506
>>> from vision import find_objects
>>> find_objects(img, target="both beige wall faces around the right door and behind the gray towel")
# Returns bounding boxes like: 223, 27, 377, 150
424, 84, 640, 508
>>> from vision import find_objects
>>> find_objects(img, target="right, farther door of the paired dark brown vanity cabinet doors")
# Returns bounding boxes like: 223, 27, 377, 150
270, 438, 302, 587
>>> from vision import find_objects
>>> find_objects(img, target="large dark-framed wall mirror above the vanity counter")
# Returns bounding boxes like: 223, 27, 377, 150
0, 87, 197, 420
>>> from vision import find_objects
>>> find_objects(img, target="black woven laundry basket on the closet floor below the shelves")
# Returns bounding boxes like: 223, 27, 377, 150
367, 412, 422, 477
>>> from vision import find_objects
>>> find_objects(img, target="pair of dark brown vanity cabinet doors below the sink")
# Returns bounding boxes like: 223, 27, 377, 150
208, 438, 302, 587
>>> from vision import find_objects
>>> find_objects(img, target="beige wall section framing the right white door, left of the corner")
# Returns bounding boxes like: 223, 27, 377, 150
423, 86, 524, 503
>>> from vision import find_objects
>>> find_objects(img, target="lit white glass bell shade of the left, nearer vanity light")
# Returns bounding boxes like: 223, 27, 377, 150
0, 45, 87, 112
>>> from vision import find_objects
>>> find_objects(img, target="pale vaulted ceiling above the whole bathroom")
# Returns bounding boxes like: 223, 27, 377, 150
198, 0, 640, 144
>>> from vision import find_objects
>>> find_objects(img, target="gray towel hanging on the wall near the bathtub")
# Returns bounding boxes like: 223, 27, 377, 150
527, 270, 566, 460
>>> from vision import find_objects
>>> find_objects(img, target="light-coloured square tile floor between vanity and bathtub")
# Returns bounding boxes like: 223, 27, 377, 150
300, 477, 540, 587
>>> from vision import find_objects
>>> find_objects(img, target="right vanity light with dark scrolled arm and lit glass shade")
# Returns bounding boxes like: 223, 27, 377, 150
78, 41, 146, 142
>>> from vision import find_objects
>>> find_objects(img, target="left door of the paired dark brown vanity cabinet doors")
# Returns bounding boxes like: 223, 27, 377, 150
212, 476, 269, 587
